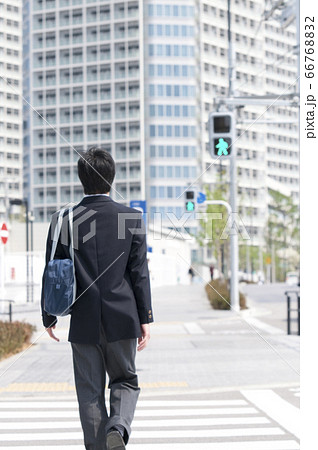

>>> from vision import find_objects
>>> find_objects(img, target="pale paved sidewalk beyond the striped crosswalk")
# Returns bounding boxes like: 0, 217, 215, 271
0, 284, 299, 394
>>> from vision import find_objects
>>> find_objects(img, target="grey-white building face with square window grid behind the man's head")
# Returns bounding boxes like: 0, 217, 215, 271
25, 0, 145, 221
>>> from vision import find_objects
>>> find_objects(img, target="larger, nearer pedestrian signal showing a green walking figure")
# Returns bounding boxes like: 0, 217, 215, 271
209, 112, 235, 158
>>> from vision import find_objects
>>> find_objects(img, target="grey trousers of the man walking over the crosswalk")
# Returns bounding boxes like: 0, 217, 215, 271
71, 327, 140, 450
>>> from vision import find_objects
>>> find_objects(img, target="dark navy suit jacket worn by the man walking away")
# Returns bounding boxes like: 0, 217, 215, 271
41, 195, 153, 344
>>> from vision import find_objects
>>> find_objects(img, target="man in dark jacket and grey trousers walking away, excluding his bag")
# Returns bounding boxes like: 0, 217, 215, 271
41, 148, 153, 450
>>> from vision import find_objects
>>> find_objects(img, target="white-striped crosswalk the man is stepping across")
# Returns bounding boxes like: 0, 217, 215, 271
0, 390, 299, 450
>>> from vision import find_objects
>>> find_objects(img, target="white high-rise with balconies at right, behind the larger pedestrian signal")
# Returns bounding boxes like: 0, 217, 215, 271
197, 0, 299, 253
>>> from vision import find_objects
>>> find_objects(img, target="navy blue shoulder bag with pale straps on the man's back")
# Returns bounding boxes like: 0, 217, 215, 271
44, 208, 76, 316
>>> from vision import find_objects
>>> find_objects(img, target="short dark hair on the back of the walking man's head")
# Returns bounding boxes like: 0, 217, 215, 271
77, 147, 115, 194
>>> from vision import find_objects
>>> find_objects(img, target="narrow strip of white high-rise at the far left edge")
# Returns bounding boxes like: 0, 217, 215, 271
0, 0, 23, 222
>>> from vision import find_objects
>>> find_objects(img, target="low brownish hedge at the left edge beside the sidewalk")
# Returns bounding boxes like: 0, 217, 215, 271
0, 320, 36, 360
